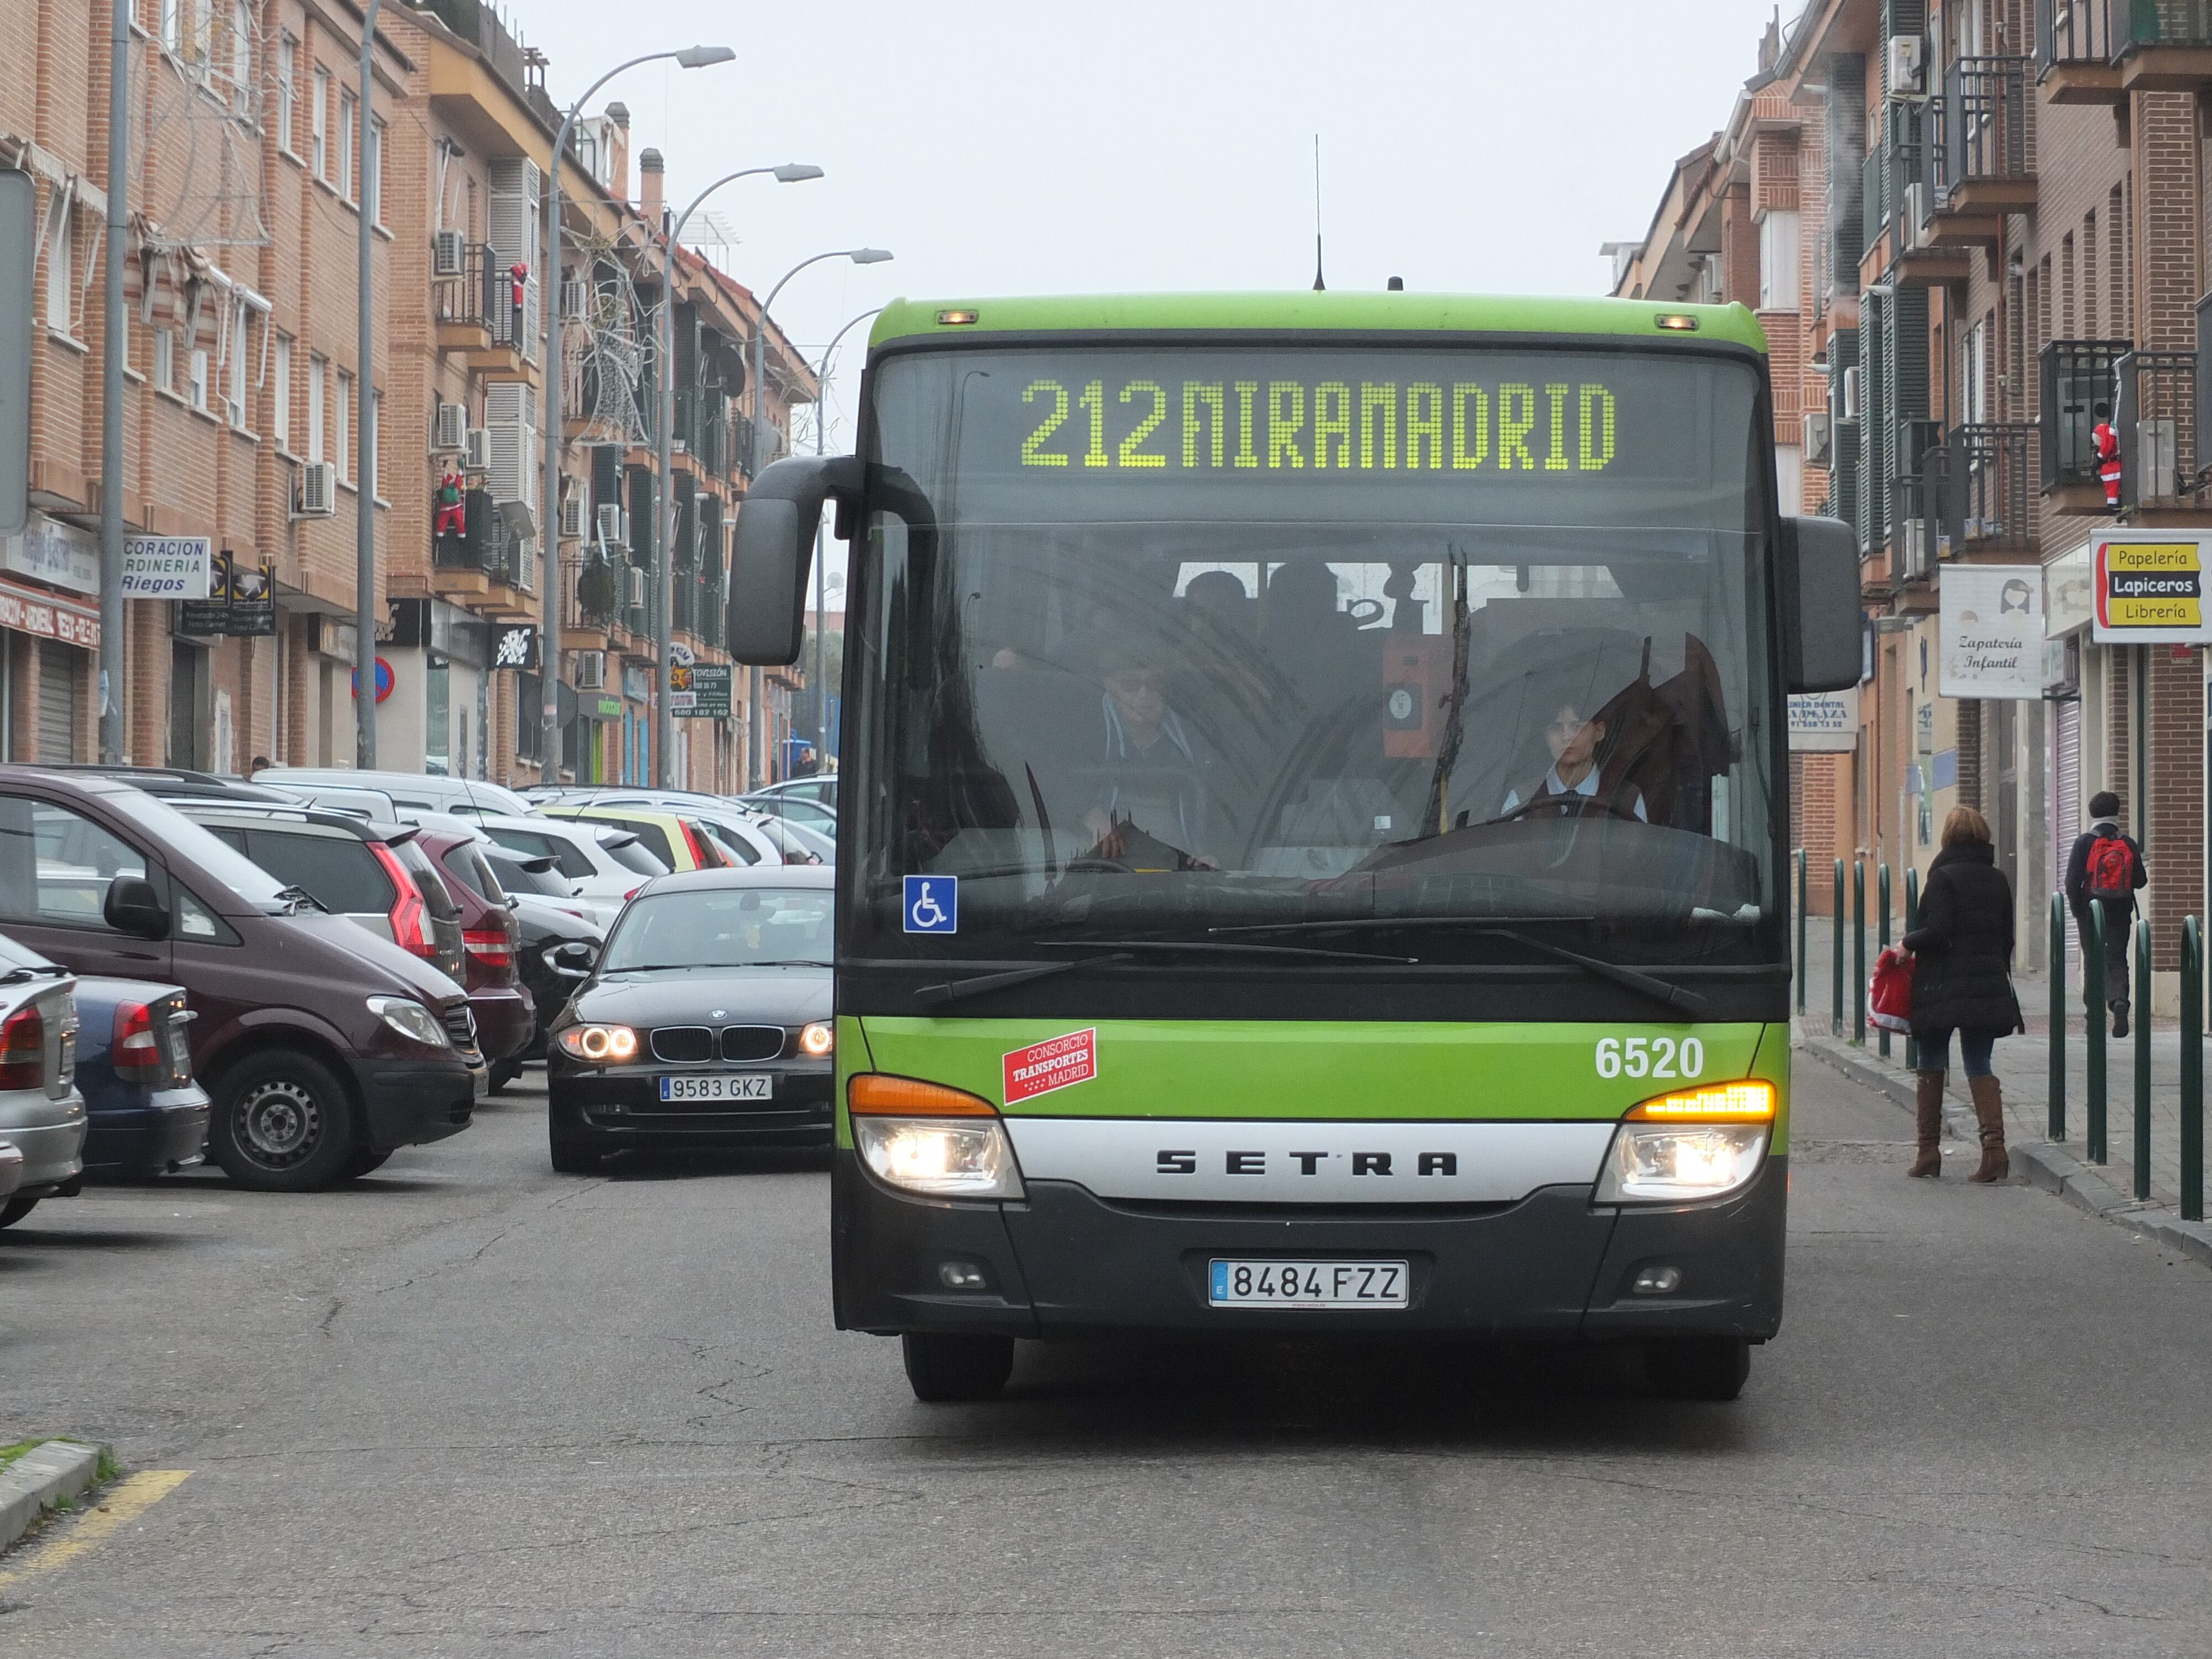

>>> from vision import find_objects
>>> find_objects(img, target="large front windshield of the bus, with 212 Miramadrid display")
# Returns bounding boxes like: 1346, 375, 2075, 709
847, 345, 1781, 962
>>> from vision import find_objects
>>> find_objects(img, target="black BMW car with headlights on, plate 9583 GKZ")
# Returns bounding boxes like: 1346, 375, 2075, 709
546, 865, 836, 1175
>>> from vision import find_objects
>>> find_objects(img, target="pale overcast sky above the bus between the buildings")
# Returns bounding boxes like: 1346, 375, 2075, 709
502, 0, 1796, 593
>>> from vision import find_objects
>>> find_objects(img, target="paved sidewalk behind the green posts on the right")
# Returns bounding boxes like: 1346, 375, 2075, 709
1792, 916, 2212, 1265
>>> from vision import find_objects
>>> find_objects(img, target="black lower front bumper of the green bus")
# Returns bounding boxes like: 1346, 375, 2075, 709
832, 1148, 1790, 1340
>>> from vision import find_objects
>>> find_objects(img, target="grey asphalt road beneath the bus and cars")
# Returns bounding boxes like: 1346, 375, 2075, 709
0, 1062, 2212, 1659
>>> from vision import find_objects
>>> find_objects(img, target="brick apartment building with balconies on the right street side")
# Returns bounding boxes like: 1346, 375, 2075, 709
1608, 0, 2212, 1000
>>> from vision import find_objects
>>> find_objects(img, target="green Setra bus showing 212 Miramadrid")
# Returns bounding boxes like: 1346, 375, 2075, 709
728, 292, 1863, 1400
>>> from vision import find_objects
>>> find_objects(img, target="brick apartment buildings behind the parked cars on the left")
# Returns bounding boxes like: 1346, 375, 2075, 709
0, 0, 814, 787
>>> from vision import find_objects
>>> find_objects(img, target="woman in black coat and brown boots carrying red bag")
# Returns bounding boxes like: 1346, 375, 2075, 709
1905, 807, 2024, 1181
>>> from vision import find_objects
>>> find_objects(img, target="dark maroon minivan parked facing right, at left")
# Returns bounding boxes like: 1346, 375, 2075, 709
0, 765, 487, 1192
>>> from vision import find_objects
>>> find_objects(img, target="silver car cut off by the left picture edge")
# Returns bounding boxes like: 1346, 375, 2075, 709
0, 938, 86, 1228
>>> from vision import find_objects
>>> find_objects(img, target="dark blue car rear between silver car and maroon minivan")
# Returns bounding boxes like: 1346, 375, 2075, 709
77, 978, 208, 1181
